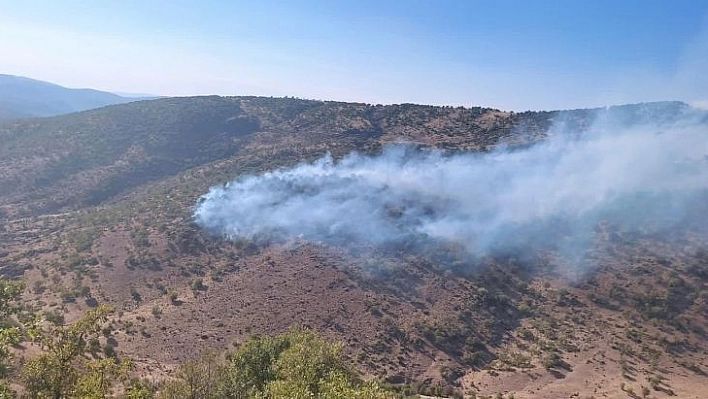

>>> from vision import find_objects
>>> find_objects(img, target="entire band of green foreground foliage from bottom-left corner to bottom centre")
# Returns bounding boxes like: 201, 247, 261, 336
0, 277, 396, 399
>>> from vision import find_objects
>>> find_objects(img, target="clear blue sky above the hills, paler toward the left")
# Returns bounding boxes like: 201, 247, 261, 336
0, 0, 708, 110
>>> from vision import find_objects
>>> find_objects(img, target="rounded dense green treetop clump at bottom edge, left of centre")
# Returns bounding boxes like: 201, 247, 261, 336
160, 330, 394, 399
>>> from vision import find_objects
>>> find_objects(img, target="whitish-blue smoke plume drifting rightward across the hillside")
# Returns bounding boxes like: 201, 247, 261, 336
195, 105, 708, 266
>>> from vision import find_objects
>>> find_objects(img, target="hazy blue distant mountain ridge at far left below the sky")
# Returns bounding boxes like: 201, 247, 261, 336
0, 74, 153, 122
